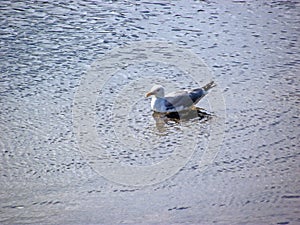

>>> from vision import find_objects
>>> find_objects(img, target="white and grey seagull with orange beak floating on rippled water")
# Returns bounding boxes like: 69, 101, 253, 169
146, 81, 216, 113
